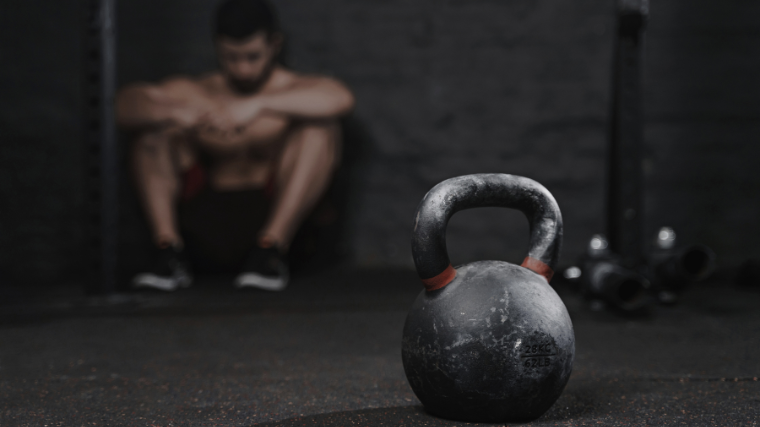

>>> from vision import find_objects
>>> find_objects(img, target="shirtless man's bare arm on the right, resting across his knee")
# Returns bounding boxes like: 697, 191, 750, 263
230, 77, 354, 123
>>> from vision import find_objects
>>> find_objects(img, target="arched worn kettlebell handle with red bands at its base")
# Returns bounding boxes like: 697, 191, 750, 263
412, 173, 562, 291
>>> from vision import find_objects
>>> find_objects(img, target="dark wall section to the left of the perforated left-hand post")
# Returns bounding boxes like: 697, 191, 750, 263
0, 1, 84, 283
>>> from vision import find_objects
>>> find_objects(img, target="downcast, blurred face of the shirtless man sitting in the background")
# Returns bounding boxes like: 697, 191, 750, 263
216, 31, 281, 93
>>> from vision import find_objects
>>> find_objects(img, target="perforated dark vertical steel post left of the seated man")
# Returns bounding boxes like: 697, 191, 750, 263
84, 0, 119, 293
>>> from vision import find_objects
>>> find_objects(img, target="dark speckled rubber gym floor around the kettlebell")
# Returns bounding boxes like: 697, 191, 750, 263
0, 271, 760, 427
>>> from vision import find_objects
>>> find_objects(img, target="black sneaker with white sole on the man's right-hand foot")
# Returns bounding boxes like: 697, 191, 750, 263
235, 247, 289, 291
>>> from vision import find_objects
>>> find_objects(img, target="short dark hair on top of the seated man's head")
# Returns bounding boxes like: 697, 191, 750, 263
214, 0, 280, 40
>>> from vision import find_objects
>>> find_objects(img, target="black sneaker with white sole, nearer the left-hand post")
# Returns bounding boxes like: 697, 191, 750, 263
132, 246, 193, 292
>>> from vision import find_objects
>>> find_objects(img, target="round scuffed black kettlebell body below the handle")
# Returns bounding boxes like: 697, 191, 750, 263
402, 261, 575, 422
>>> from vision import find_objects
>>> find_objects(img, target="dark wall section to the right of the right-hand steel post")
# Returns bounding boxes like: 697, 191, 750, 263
644, 0, 760, 266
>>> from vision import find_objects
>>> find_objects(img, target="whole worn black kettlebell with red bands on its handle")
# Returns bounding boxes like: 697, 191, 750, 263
401, 174, 575, 422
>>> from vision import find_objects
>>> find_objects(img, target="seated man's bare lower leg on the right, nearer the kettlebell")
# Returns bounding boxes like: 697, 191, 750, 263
260, 121, 340, 252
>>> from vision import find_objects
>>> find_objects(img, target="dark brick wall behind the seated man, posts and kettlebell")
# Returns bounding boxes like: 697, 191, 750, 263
0, 0, 760, 283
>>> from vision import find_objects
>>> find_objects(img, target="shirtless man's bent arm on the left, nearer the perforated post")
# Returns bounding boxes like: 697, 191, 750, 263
116, 80, 205, 130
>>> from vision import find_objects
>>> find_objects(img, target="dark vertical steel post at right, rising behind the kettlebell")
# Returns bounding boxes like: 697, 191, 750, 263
607, 0, 649, 268
